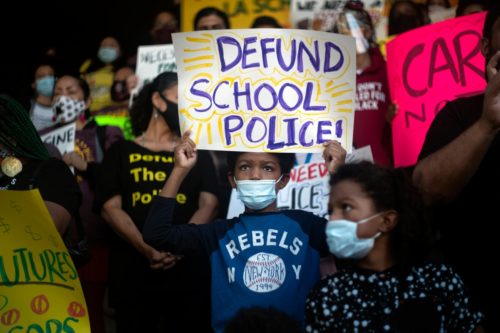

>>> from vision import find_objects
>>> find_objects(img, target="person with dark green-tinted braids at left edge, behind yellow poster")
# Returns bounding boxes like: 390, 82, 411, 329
0, 95, 81, 236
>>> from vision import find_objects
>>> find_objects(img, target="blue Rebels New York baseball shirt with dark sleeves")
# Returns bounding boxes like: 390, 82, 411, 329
143, 197, 328, 332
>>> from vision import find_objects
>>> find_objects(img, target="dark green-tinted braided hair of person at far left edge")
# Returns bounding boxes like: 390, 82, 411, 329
0, 95, 49, 160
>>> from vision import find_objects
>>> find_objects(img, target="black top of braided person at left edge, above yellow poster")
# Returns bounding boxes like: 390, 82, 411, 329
0, 158, 81, 217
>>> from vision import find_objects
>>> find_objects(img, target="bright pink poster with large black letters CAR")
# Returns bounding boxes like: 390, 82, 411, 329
387, 13, 486, 167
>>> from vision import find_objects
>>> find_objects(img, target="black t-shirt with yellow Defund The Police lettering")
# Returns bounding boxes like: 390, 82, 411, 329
96, 141, 216, 296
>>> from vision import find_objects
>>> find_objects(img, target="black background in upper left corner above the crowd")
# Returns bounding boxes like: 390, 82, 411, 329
0, 0, 180, 105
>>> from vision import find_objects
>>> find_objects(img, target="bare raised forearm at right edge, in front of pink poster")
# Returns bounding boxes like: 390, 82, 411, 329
413, 52, 500, 204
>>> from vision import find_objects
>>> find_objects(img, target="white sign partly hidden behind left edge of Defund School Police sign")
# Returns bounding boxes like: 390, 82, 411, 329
131, 44, 177, 100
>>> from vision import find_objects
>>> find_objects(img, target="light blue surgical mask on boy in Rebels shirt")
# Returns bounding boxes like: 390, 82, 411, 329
234, 175, 283, 210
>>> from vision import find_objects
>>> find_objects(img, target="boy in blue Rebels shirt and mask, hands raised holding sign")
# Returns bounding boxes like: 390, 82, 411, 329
143, 134, 346, 332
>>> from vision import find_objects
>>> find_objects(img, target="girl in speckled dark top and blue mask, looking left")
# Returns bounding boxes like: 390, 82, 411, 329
306, 162, 483, 333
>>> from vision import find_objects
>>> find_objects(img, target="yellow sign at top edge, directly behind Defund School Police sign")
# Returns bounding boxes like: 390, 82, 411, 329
181, 0, 290, 32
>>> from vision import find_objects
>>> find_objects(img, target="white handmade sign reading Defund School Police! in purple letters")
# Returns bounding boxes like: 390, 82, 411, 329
173, 29, 356, 152
